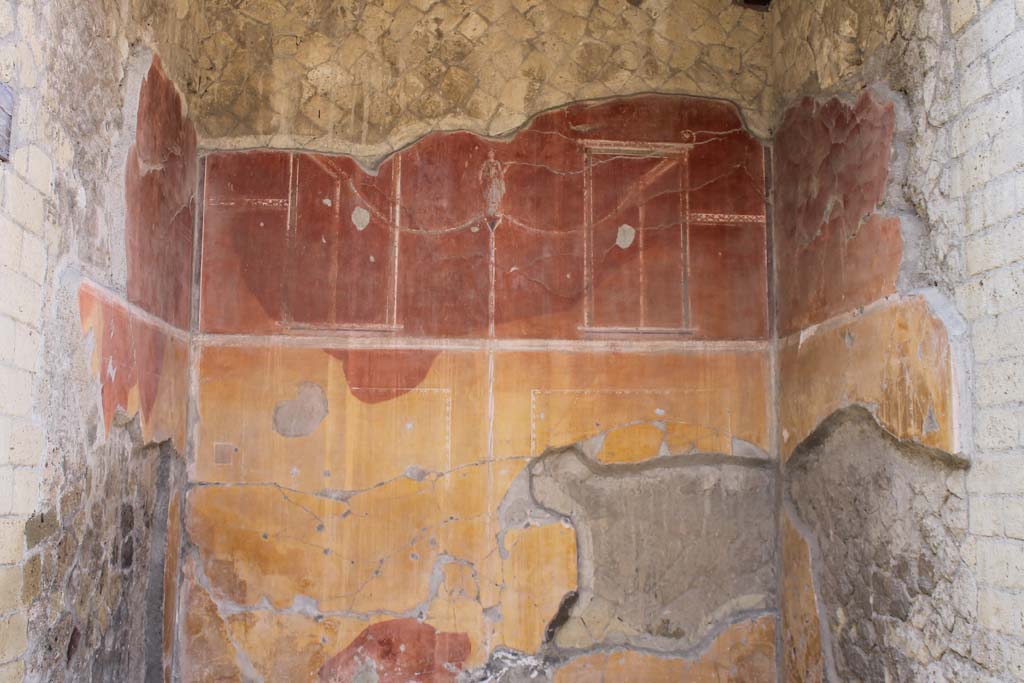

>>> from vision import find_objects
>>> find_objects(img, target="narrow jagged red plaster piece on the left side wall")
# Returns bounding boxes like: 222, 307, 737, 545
125, 57, 197, 329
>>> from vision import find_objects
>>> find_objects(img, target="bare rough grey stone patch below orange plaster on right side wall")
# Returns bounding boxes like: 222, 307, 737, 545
785, 407, 978, 681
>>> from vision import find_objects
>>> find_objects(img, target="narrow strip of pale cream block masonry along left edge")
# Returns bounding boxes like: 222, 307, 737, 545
0, 0, 53, 681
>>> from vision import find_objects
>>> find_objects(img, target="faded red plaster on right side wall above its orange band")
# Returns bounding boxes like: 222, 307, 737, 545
774, 92, 903, 335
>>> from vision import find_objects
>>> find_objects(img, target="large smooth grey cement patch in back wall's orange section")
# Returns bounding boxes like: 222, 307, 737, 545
529, 447, 776, 651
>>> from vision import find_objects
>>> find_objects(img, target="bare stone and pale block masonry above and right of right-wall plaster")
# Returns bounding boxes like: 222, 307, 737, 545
770, 0, 1024, 680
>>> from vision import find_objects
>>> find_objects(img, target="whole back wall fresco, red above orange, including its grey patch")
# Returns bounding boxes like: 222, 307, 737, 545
179, 96, 775, 681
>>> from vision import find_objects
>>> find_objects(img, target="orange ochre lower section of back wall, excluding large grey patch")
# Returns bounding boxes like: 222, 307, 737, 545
186, 346, 769, 671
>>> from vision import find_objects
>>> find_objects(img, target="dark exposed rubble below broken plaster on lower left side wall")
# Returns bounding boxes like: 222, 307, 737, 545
25, 419, 185, 683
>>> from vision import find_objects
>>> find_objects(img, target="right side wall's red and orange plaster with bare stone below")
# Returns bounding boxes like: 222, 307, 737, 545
773, 90, 975, 682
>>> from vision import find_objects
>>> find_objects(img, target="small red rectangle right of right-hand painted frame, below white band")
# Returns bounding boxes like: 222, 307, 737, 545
689, 224, 768, 339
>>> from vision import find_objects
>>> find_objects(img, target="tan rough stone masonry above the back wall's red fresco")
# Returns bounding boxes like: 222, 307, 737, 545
128, 0, 771, 160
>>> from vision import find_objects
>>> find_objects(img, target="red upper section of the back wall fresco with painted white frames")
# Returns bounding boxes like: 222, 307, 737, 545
202, 95, 768, 339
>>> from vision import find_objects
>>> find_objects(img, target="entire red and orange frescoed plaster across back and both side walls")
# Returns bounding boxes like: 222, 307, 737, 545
64, 61, 974, 682
